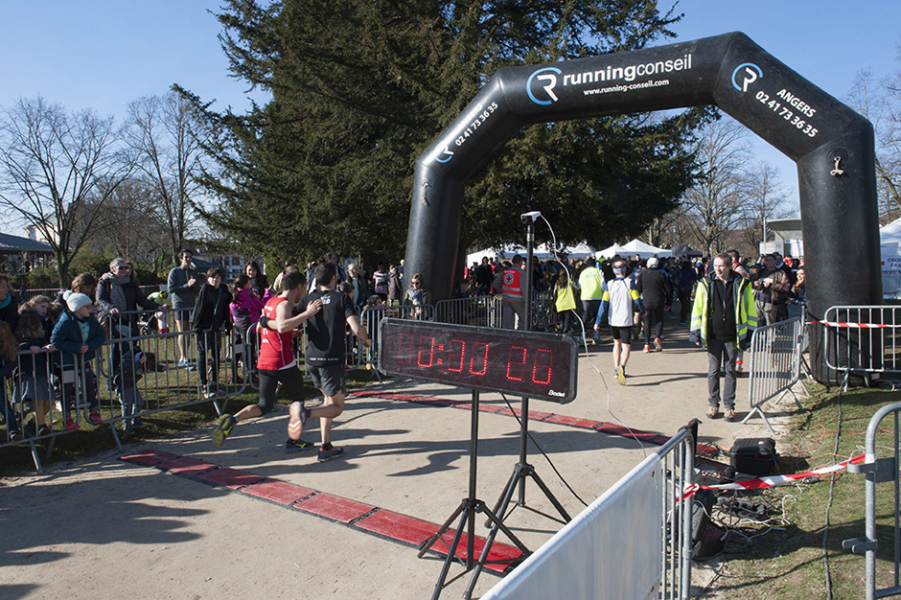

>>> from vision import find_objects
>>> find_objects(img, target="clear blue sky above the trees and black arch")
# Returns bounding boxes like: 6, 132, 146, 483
0, 0, 901, 211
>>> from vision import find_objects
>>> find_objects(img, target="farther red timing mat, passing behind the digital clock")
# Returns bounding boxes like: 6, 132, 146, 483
348, 391, 719, 458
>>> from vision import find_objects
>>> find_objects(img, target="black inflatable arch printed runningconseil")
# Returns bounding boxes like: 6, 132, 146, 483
405, 32, 882, 381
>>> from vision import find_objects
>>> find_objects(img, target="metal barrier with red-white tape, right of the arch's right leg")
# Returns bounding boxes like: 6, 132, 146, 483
810, 306, 901, 389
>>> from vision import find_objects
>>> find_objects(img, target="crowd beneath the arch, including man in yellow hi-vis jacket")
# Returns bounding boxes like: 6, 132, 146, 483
461, 250, 806, 421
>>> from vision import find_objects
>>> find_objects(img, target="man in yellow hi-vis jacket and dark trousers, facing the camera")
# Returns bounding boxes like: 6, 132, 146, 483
688, 253, 757, 421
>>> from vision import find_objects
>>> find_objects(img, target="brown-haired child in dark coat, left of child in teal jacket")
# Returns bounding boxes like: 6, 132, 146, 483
13, 314, 53, 437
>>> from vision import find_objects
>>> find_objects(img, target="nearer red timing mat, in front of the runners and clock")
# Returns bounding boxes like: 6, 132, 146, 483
119, 449, 522, 574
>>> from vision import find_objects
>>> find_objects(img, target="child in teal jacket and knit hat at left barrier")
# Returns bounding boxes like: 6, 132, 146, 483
50, 293, 106, 431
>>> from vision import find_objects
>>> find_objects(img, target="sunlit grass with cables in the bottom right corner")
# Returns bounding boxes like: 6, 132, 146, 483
702, 385, 901, 600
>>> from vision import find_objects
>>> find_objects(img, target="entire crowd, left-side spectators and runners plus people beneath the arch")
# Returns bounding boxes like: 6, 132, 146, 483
0, 244, 806, 450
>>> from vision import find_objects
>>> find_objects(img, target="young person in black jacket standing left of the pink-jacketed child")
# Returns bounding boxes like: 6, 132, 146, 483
191, 267, 232, 395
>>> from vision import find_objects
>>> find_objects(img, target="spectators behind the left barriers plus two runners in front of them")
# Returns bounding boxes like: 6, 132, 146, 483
0, 249, 412, 461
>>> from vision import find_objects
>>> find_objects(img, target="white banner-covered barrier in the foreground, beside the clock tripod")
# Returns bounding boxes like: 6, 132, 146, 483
482, 428, 694, 600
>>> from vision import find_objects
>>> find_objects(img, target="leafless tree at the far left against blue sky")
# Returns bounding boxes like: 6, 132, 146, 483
0, 97, 132, 287
